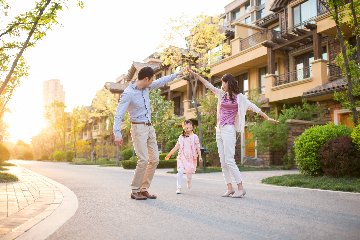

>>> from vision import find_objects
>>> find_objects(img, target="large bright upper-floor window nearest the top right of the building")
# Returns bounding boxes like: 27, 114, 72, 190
293, 0, 317, 27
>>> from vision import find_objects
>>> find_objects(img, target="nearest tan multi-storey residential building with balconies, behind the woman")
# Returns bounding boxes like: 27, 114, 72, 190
211, 0, 354, 164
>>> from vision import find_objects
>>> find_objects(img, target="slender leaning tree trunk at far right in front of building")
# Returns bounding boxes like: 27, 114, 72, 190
334, 5, 358, 126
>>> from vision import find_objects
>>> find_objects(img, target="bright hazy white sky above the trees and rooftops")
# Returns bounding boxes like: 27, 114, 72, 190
5, 0, 231, 143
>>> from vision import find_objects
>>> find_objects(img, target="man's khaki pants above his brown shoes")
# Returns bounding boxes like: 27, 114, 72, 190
131, 124, 159, 193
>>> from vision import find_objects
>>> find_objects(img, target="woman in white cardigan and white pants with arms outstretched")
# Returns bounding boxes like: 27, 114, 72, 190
188, 69, 277, 198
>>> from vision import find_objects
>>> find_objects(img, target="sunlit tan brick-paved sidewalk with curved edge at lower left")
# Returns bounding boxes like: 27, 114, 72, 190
0, 166, 63, 240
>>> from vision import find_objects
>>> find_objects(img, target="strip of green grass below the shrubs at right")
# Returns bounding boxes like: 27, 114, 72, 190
262, 174, 360, 192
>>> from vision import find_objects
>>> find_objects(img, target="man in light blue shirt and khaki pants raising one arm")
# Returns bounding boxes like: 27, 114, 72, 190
114, 67, 181, 200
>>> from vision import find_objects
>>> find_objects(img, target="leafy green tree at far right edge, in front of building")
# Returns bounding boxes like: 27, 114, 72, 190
320, 0, 360, 125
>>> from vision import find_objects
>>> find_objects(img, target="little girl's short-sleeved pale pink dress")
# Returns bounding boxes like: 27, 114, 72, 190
177, 134, 200, 173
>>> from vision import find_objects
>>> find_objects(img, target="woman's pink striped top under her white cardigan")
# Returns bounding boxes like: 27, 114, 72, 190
218, 95, 238, 126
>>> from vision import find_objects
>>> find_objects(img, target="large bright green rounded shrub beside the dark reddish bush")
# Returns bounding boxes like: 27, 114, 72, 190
294, 124, 351, 176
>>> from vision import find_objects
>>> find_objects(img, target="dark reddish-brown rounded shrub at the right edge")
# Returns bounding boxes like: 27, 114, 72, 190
319, 136, 360, 177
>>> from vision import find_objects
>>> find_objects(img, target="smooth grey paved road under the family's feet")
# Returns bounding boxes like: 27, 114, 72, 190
15, 161, 360, 240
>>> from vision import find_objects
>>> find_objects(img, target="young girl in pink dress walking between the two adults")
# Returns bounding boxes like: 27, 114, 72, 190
165, 120, 202, 194
